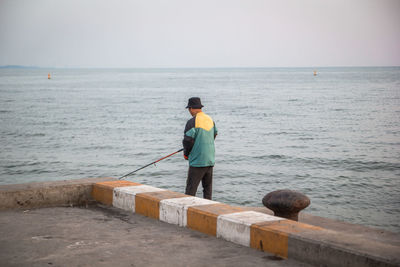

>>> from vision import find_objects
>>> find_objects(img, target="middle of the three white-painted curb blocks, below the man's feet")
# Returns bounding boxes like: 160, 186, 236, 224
160, 197, 219, 226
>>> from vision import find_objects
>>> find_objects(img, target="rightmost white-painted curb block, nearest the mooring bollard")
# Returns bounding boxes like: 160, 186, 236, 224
217, 211, 285, 247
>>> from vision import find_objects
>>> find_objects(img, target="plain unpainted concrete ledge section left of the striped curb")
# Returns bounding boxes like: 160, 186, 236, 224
0, 177, 113, 210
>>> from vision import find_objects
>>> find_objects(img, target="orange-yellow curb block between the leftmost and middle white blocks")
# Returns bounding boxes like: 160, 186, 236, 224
135, 190, 187, 220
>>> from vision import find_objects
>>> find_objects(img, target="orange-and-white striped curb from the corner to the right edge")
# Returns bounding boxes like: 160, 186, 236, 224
93, 181, 400, 267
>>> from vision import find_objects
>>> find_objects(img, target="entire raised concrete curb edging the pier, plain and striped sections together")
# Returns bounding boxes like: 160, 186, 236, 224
0, 178, 400, 266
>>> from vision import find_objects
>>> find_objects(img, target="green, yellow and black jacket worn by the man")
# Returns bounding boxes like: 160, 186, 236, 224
182, 112, 218, 167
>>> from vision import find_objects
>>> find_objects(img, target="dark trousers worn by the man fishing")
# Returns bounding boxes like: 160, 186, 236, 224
185, 166, 214, 199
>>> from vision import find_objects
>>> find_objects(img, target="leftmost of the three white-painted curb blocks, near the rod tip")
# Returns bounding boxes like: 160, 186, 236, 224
113, 185, 165, 212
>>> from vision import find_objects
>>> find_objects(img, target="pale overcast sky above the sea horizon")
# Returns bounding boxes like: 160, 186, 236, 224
0, 0, 400, 68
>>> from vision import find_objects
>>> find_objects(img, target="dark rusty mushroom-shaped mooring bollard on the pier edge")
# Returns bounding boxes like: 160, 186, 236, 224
262, 189, 310, 221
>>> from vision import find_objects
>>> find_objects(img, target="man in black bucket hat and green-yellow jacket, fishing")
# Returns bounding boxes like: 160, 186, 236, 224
182, 97, 217, 199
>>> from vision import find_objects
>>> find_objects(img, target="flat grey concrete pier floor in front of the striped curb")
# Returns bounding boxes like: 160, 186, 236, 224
0, 205, 310, 267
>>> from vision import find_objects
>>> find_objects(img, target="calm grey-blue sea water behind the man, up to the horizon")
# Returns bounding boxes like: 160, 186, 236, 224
0, 67, 400, 233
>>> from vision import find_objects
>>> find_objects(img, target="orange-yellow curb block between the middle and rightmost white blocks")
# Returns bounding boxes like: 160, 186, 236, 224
187, 204, 243, 236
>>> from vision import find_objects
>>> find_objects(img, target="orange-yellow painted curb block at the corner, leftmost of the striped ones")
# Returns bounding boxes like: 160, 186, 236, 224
92, 181, 140, 206
